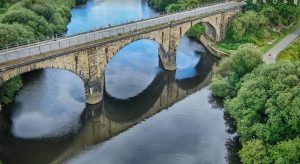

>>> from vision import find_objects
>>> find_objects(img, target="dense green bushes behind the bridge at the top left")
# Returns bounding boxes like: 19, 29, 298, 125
0, 0, 75, 46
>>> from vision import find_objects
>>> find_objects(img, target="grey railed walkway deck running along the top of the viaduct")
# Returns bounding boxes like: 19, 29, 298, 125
0, 2, 244, 63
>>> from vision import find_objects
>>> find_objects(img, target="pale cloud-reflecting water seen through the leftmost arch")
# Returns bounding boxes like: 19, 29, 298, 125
2, 68, 86, 139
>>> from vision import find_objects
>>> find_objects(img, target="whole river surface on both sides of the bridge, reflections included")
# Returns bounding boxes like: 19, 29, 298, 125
0, 0, 239, 164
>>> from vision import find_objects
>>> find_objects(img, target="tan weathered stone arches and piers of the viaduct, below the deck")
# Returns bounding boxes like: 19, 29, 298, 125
0, 9, 240, 104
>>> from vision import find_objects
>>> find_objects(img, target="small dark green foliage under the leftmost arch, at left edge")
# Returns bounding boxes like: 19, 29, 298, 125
0, 76, 22, 105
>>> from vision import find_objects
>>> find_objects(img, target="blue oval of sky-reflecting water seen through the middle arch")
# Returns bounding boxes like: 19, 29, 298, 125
104, 39, 162, 100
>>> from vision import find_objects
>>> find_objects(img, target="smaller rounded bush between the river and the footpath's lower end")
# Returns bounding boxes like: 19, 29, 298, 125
209, 44, 262, 98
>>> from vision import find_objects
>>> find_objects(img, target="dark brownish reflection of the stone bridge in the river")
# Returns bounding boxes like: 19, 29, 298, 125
0, 54, 215, 164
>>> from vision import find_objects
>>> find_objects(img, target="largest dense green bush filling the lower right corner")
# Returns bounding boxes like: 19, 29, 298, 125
225, 61, 300, 163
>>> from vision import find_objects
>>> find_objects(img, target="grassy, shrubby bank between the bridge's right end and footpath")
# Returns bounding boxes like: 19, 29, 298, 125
216, 1, 300, 53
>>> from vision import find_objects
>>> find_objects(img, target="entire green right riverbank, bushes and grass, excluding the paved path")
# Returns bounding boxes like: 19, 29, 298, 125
210, 1, 300, 164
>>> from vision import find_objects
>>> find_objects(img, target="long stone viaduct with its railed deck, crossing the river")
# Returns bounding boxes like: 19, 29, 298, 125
0, 2, 244, 104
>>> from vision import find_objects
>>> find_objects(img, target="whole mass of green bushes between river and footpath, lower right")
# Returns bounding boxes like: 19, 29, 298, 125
209, 44, 300, 164
